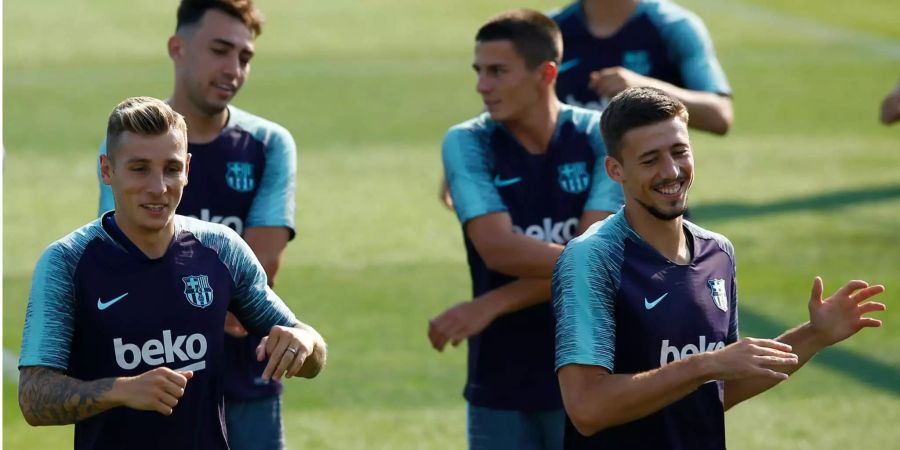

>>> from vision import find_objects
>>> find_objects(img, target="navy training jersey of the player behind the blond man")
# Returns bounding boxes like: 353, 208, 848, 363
100, 106, 297, 400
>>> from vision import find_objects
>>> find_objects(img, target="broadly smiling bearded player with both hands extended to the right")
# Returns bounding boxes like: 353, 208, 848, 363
553, 88, 885, 450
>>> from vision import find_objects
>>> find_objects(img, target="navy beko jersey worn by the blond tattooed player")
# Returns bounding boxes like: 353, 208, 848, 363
19, 212, 297, 450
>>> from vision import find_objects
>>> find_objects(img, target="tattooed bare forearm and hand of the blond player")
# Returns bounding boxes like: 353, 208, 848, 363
19, 366, 193, 426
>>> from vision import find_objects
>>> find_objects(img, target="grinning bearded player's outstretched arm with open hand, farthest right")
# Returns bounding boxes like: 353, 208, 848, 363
725, 277, 885, 410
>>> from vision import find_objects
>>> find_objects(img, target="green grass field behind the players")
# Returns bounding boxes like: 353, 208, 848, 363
3, 0, 900, 450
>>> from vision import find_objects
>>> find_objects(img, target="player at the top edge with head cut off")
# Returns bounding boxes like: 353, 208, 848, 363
551, 0, 733, 134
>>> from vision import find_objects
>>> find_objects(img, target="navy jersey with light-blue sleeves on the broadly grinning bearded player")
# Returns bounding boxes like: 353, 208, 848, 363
553, 211, 738, 450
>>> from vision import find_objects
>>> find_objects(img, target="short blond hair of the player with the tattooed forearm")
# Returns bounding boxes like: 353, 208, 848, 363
106, 97, 187, 160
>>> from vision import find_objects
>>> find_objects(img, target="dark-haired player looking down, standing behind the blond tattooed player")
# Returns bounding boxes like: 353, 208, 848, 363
100, 0, 297, 450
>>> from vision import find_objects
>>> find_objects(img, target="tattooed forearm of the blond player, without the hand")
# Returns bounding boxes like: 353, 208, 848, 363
19, 367, 115, 425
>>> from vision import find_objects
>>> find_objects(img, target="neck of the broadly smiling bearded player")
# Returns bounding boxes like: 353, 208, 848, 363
625, 205, 691, 265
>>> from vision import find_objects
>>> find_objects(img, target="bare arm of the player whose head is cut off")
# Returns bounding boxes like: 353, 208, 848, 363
589, 67, 734, 135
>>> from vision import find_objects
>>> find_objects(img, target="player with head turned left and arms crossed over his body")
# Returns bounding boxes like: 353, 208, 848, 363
429, 10, 622, 450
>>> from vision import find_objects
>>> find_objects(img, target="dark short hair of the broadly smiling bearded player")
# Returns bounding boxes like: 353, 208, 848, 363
600, 87, 688, 162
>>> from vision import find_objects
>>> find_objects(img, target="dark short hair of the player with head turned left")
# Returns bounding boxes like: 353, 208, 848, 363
475, 9, 562, 69
